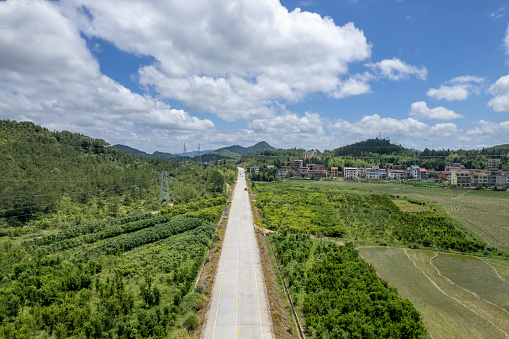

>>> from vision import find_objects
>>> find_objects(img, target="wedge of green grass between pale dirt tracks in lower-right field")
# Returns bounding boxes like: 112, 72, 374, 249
433, 253, 509, 317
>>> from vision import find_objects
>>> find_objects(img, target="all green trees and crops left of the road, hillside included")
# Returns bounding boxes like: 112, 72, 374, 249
0, 121, 236, 339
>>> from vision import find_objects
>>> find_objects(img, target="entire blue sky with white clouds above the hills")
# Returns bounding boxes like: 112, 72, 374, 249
0, 0, 509, 153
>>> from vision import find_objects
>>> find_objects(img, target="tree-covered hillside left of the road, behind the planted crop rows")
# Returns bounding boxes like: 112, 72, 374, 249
0, 121, 235, 231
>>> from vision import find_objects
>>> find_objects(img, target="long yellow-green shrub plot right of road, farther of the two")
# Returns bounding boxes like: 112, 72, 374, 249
253, 183, 485, 252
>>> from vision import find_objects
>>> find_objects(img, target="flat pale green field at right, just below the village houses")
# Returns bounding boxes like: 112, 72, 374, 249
292, 180, 509, 252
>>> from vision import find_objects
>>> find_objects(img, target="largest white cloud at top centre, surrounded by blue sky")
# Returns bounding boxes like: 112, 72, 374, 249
61, 0, 371, 121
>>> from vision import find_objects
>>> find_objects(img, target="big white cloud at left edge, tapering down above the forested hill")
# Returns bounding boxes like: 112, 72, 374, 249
0, 0, 214, 145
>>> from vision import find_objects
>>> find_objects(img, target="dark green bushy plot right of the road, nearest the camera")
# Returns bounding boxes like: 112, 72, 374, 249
271, 232, 425, 338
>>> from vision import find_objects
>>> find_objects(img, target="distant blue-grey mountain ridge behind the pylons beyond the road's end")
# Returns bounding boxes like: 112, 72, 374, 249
111, 141, 276, 161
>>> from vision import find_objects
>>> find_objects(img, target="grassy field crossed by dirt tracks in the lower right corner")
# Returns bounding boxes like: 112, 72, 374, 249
360, 247, 509, 338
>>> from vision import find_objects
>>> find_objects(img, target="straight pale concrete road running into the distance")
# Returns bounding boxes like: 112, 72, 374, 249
202, 168, 274, 339
